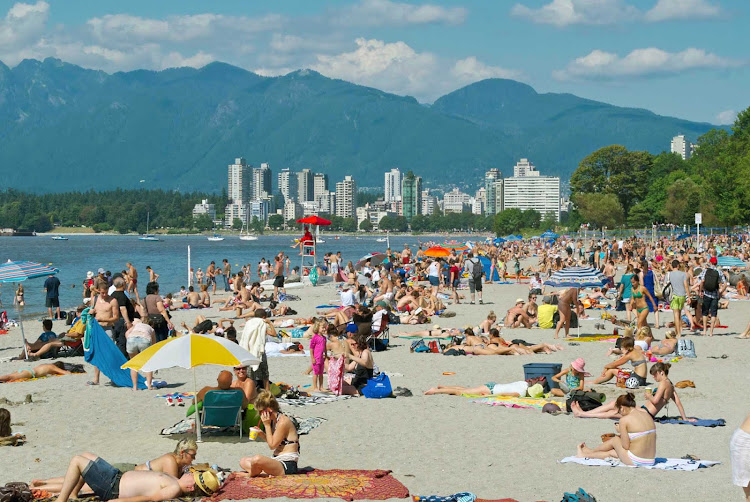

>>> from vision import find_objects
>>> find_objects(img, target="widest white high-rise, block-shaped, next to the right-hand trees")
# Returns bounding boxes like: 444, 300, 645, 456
503, 159, 560, 221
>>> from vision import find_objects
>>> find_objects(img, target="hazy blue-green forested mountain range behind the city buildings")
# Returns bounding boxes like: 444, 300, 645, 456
0, 58, 714, 192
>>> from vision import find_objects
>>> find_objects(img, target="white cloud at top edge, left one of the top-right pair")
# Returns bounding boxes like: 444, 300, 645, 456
511, 0, 641, 27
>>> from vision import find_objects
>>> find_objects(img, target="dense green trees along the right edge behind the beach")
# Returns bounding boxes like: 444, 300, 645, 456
568, 108, 750, 229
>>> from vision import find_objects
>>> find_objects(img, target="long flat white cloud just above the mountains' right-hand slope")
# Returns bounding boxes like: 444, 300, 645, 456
553, 47, 742, 80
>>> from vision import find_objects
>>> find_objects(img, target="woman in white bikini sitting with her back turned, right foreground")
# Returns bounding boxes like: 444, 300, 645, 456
576, 392, 656, 467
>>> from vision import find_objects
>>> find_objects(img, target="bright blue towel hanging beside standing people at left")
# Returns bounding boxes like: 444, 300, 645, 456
81, 309, 146, 390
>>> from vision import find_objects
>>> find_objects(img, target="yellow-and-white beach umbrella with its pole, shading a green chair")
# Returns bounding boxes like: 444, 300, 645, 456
122, 334, 260, 441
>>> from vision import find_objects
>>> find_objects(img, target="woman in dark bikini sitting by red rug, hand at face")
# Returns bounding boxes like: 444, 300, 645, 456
240, 390, 300, 477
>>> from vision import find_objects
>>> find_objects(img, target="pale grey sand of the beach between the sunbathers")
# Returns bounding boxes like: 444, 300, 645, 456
0, 276, 750, 502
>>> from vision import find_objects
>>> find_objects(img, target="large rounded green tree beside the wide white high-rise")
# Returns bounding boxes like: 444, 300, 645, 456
570, 145, 653, 213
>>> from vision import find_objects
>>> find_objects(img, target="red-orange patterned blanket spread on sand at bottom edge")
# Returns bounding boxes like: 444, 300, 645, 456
204, 469, 409, 502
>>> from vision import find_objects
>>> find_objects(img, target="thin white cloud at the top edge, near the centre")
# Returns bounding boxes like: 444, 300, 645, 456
336, 0, 467, 26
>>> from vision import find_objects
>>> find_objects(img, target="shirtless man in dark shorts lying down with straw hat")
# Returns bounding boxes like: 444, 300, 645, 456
48, 453, 219, 502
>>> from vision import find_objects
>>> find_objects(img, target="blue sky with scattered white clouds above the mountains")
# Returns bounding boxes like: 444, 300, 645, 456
0, 0, 750, 124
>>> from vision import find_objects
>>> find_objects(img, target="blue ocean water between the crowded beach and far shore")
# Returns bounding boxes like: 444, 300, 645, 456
0, 234, 424, 319
